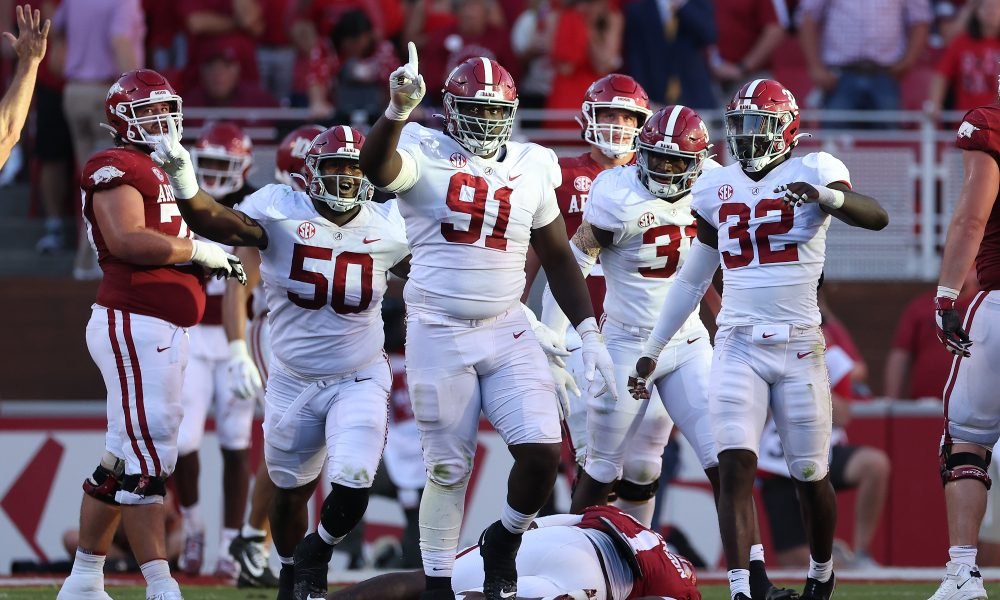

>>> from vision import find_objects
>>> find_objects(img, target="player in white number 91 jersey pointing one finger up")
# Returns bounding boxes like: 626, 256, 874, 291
361, 43, 617, 600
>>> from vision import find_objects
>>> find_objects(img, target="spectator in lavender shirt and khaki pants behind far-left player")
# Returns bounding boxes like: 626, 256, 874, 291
52, 0, 146, 279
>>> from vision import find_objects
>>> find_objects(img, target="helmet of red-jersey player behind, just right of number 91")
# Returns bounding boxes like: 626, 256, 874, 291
576, 73, 653, 159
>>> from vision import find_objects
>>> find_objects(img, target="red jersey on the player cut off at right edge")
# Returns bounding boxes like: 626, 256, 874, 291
955, 104, 1000, 291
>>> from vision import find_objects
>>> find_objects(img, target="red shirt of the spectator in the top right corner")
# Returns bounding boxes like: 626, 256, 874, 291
937, 33, 1000, 110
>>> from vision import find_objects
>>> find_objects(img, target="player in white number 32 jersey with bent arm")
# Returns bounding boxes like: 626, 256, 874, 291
629, 79, 889, 600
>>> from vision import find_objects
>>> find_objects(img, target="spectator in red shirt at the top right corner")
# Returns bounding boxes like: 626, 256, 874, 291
925, 0, 1000, 119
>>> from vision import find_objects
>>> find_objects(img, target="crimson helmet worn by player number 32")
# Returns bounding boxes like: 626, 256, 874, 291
725, 79, 808, 173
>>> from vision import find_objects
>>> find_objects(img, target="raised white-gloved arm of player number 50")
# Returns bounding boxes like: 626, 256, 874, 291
151, 119, 267, 248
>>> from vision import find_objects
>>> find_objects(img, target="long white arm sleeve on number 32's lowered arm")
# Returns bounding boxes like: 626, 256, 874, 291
642, 240, 719, 358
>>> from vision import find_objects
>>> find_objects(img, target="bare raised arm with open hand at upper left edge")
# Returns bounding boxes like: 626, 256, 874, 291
0, 4, 52, 167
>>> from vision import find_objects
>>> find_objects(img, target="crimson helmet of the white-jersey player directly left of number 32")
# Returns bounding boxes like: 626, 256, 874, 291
636, 104, 712, 199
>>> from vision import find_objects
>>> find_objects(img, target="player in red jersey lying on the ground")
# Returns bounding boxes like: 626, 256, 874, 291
327, 506, 701, 600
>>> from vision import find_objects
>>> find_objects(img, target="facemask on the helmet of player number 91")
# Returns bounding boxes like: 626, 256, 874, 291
444, 92, 518, 157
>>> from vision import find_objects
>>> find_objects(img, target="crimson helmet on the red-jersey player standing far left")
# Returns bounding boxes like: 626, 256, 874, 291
104, 69, 183, 147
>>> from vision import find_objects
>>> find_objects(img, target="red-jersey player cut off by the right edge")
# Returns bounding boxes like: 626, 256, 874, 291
932, 94, 1000, 600
